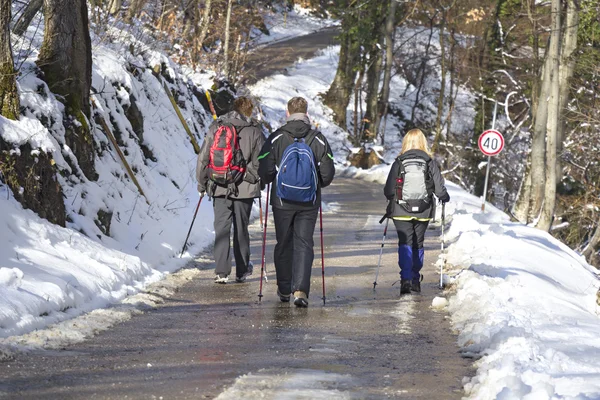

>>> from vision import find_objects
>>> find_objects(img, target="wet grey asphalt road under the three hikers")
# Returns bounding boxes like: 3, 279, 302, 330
0, 179, 472, 399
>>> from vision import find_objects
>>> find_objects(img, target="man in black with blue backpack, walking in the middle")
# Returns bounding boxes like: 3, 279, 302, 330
258, 97, 335, 307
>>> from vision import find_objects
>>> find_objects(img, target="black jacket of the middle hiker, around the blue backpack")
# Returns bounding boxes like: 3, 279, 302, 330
258, 114, 335, 210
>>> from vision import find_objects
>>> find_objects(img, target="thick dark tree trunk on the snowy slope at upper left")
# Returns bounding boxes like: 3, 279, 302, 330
37, 0, 97, 179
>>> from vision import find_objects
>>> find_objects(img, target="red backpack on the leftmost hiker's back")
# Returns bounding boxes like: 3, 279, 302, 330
207, 121, 246, 186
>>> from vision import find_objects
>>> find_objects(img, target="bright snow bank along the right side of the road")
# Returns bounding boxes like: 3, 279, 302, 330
446, 185, 600, 399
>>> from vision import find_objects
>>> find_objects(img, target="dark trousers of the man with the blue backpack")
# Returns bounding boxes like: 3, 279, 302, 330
273, 207, 319, 296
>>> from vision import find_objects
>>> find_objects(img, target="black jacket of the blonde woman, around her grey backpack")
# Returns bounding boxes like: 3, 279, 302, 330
383, 150, 450, 220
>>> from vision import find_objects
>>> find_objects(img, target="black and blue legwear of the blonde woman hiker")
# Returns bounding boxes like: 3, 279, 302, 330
394, 220, 429, 281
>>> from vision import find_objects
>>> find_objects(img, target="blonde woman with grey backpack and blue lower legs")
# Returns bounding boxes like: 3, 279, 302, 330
383, 129, 450, 294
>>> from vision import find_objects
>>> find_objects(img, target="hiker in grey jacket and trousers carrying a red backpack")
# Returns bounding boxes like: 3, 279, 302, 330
196, 97, 264, 284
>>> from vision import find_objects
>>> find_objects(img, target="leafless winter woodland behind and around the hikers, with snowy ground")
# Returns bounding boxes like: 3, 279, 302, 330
0, 0, 600, 267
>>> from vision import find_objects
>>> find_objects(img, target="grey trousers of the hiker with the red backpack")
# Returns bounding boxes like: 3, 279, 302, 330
213, 197, 254, 277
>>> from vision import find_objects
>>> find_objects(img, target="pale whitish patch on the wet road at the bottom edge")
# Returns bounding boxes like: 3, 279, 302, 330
216, 369, 356, 400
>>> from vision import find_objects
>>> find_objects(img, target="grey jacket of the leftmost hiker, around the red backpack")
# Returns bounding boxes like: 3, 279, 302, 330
196, 111, 265, 199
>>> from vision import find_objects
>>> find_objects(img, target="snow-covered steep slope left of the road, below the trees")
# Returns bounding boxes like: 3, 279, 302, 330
0, 23, 213, 338
